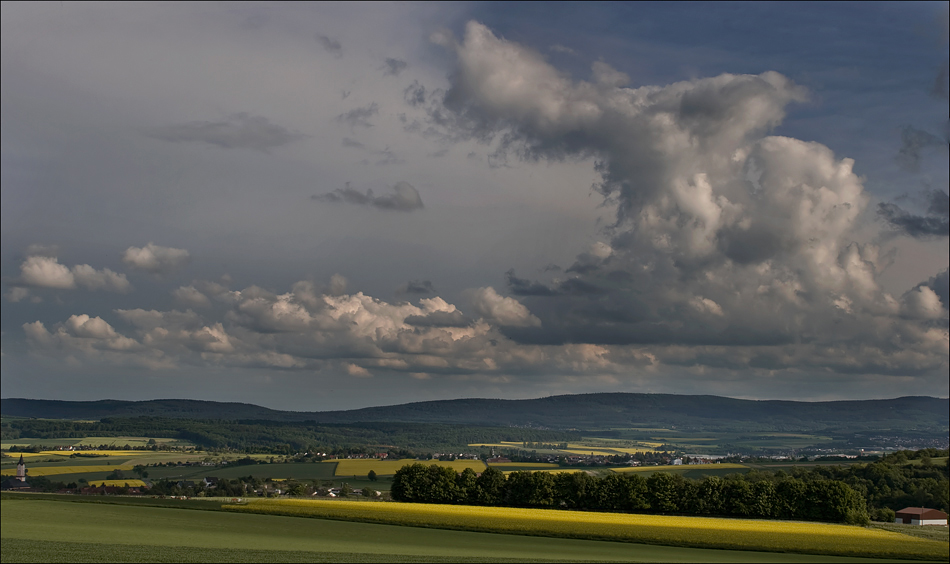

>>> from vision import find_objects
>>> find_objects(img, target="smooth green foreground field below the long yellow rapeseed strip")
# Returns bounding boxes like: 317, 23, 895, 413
0, 495, 928, 562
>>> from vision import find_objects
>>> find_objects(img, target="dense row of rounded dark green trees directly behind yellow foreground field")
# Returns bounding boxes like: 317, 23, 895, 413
391, 464, 869, 524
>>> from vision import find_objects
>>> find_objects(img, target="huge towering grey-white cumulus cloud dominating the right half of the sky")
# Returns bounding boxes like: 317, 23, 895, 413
407, 22, 947, 371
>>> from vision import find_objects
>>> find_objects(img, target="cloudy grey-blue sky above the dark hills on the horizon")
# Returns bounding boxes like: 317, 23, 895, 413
0, 2, 950, 411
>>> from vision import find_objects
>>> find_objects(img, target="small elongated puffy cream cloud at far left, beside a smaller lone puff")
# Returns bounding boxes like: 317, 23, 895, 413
19, 256, 132, 290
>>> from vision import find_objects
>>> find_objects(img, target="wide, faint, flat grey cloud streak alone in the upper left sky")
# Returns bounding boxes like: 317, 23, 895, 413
146, 113, 306, 153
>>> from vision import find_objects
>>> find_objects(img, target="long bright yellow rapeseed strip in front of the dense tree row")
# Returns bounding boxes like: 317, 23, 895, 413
224, 499, 948, 561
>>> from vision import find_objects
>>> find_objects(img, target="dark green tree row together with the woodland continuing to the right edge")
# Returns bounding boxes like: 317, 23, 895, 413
392, 449, 950, 524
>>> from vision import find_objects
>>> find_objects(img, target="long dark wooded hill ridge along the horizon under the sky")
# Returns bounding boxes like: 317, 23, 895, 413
0, 393, 950, 432
